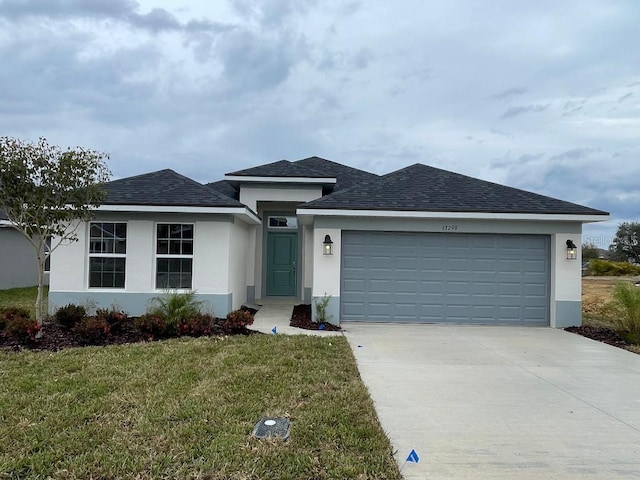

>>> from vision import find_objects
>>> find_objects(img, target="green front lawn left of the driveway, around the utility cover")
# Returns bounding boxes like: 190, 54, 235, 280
0, 335, 401, 480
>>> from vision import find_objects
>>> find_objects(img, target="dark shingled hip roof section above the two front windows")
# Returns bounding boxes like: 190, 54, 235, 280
104, 169, 244, 207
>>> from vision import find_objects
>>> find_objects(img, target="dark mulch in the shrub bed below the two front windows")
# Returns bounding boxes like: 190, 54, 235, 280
0, 318, 258, 352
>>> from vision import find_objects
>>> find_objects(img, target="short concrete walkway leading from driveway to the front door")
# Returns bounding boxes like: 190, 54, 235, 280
248, 297, 342, 337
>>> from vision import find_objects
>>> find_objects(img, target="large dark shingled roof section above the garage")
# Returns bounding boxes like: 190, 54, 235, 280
301, 163, 607, 215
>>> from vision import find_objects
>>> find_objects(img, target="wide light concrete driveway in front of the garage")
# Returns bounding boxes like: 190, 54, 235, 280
342, 322, 640, 479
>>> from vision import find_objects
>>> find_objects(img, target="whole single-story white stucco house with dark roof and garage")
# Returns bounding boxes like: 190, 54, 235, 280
49, 157, 608, 327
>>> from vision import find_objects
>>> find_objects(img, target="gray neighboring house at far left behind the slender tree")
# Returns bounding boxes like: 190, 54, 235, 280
0, 210, 48, 290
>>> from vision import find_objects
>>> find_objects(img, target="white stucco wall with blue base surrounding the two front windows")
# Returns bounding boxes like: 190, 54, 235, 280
49, 212, 253, 316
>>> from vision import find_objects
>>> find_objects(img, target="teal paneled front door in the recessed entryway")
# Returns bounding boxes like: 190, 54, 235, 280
267, 232, 298, 297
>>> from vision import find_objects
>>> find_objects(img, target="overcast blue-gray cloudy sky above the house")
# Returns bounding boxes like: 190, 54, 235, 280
0, 0, 640, 247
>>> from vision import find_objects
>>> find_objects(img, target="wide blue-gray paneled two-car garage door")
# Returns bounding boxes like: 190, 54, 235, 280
340, 231, 550, 325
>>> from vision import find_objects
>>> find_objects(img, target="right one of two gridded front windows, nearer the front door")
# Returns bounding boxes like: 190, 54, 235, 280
156, 223, 193, 289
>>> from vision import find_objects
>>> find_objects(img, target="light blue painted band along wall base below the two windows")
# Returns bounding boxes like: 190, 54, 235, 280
49, 291, 233, 317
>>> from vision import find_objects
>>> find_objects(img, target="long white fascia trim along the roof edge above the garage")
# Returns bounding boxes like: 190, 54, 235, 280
296, 208, 609, 223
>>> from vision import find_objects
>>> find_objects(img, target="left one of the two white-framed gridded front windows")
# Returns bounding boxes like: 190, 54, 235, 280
89, 222, 127, 288
